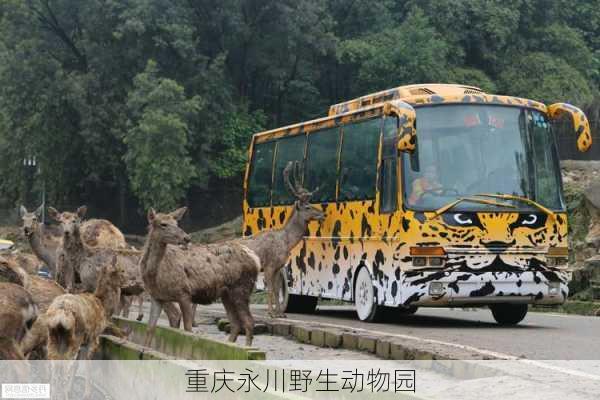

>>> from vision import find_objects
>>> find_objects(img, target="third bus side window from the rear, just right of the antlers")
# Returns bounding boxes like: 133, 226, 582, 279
305, 128, 340, 203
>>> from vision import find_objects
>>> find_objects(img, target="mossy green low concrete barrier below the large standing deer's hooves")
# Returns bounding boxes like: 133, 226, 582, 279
112, 317, 266, 360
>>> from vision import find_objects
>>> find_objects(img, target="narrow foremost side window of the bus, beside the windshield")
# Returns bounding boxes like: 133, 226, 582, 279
380, 117, 398, 213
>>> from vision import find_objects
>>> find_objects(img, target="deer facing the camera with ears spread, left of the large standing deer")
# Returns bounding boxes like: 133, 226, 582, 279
48, 206, 180, 327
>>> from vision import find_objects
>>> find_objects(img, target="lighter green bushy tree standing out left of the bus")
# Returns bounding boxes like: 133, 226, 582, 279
124, 61, 202, 210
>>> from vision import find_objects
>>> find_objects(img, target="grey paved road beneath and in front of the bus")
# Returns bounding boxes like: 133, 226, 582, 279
205, 305, 600, 360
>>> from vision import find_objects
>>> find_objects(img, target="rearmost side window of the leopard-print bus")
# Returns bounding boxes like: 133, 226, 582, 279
248, 142, 275, 207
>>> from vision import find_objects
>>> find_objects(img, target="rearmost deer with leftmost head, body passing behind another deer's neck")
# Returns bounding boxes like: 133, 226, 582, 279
19, 206, 127, 276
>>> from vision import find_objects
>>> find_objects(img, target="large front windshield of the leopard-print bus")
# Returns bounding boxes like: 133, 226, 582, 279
402, 104, 564, 211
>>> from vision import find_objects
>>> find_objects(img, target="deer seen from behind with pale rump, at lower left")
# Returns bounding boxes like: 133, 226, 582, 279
45, 256, 123, 360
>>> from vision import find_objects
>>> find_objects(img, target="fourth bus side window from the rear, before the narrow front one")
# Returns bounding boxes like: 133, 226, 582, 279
339, 119, 381, 200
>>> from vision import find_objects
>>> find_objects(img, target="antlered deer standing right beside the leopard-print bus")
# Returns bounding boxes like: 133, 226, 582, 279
241, 161, 324, 318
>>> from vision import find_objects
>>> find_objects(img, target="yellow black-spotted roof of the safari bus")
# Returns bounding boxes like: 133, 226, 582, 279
254, 83, 546, 143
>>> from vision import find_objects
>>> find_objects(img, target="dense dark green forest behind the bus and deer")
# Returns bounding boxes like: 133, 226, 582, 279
0, 0, 600, 229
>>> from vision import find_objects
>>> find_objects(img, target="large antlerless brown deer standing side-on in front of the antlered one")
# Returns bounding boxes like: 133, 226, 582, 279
140, 207, 260, 346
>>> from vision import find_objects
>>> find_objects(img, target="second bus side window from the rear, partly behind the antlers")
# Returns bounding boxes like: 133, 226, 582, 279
273, 135, 306, 205
